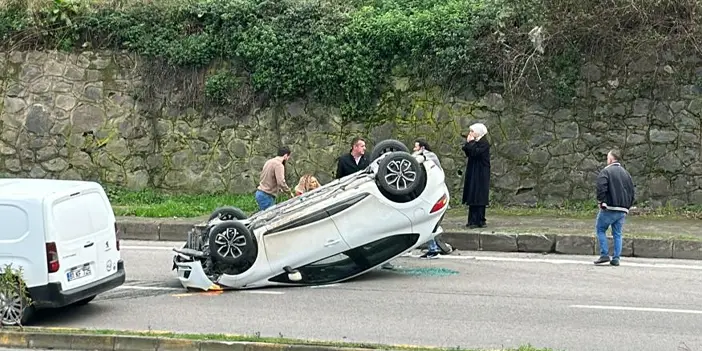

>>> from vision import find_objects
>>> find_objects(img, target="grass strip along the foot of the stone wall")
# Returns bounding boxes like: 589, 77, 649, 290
105, 186, 702, 220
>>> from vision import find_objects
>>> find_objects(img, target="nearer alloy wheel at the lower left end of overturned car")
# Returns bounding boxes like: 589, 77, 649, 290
208, 220, 258, 265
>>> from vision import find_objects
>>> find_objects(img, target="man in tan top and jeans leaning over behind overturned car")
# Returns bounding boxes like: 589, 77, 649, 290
255, 146, 293, 211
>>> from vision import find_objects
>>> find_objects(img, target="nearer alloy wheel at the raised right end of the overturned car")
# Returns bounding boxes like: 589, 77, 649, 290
376, 151, 424, 196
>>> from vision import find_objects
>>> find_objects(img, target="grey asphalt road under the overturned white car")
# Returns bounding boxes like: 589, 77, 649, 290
27, 241, 702, 351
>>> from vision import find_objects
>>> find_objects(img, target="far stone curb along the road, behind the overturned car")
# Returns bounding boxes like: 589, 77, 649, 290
117, 217, 702, 260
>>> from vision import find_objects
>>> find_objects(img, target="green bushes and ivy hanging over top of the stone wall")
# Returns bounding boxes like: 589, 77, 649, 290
0, 0, 702, 118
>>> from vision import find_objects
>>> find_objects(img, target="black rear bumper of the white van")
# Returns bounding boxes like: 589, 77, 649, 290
28, 260, 126, 308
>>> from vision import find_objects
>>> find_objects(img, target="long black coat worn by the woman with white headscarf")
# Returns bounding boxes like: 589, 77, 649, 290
462, 138, 490, 206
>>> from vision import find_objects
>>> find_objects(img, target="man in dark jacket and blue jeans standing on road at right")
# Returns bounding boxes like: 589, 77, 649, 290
595, 150, 634, 266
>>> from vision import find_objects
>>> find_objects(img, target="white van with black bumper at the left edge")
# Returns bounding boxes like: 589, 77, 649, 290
0, 178, 125, 325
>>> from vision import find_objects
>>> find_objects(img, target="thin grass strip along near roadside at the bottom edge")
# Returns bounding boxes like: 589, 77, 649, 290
0, 327, 555, 351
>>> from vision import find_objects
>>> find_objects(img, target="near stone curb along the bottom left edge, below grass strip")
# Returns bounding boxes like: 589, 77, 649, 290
0, 327, 382, 351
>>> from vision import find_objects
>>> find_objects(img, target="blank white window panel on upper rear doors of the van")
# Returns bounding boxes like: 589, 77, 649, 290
52, 192, 109, 241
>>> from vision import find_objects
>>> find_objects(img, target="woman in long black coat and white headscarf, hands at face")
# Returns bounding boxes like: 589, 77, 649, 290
462, 123, 490, 228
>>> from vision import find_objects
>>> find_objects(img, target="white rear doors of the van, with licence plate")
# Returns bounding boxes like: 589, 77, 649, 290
47, 184, 120, 290
